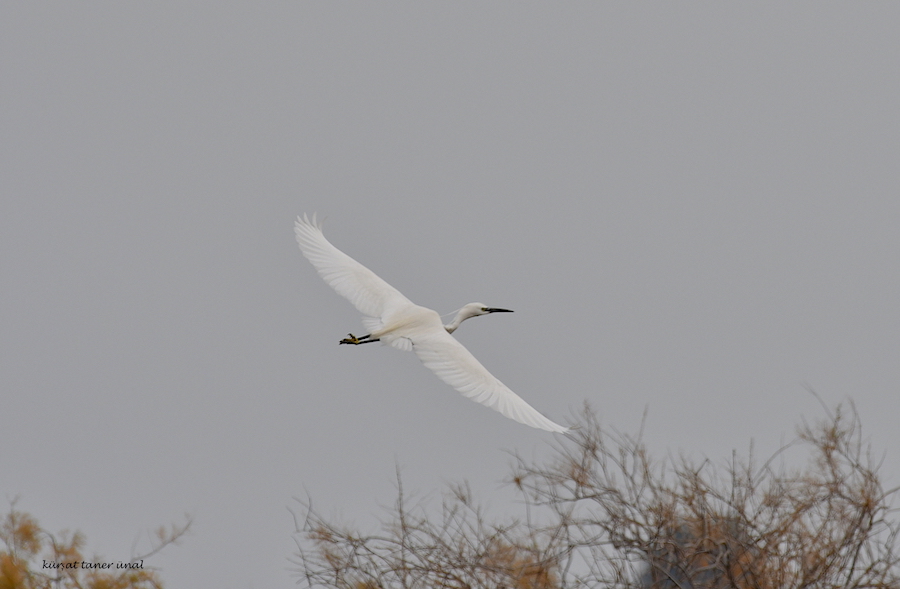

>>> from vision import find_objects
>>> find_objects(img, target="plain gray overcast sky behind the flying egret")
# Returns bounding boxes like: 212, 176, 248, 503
0, 2, 900, 589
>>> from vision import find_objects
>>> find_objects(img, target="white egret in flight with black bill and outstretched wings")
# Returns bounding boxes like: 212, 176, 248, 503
294, 214, 568, 433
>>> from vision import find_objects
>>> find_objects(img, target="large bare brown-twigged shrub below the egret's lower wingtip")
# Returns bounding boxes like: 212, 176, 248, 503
296, 405, 900, 589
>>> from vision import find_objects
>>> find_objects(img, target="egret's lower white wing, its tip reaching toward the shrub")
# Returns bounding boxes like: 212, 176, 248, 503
413, 331, 569, 433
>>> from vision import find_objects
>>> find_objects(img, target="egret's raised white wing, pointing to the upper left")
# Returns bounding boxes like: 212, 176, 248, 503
294, 214, 413, 317
